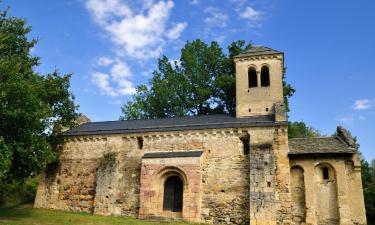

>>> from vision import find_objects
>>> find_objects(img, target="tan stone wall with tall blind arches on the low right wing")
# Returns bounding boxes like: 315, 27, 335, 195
290, 154, 366, 225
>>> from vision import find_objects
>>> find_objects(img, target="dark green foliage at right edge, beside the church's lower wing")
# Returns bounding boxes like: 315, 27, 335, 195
361, 159, 375, 225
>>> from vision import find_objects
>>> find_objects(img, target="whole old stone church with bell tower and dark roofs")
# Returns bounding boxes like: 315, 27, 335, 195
35, 46, 366, 225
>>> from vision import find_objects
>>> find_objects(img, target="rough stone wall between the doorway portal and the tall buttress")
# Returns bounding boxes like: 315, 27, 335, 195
202, 131, 250, 224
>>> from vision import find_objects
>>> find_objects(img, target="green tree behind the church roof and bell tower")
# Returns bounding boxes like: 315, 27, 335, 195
120, 39, 295, 119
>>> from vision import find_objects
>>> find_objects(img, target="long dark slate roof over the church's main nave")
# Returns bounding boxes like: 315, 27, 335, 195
63, 115, 286, 136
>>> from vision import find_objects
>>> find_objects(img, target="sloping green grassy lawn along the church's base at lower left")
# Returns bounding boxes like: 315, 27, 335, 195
0, 204, 201, 225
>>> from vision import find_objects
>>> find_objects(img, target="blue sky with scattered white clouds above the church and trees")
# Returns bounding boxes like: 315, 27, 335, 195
0, 0, 375, 160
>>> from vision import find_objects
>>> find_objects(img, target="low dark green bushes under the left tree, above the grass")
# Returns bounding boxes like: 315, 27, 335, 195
0, 177, 39, 206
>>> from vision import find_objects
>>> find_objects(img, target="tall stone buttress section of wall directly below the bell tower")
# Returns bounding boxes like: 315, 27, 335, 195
248, 126, 291, 225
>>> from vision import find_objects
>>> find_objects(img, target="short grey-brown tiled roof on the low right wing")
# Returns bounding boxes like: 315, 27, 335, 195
289, 137, 356, 155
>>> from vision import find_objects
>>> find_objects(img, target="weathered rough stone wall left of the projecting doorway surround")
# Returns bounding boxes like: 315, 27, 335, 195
35, 135, 143, 216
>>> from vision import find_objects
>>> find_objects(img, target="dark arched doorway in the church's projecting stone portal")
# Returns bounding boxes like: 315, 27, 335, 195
163, 176, 184, 212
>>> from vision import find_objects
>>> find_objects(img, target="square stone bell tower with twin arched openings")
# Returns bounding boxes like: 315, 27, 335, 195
234, 46, 286, 121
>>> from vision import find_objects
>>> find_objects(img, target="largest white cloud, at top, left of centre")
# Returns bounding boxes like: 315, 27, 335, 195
86, 0, 187, 60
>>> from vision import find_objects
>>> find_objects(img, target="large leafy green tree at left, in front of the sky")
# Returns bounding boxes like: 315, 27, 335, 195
0, 10, 77, 181
